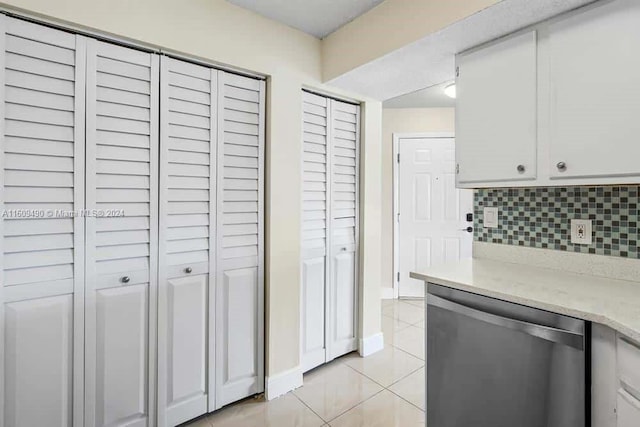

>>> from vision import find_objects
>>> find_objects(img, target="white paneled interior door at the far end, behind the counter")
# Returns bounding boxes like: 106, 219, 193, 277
397, 138, 473, 298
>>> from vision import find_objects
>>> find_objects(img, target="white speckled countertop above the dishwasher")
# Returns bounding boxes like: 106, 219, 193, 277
411, 258, 640, 342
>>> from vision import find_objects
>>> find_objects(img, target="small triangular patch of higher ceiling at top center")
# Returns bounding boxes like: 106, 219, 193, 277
227, 0, 383, 39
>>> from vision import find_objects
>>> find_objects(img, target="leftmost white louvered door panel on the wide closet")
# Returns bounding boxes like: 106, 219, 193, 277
0, 15, 85, 427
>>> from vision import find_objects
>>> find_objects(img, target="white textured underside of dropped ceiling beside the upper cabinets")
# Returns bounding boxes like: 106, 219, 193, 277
327, 0, 605, 100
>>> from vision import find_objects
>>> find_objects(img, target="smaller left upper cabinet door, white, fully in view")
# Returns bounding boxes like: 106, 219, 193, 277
456, 31, 537, 186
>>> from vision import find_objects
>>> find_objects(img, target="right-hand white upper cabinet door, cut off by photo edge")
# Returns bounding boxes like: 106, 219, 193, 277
549, 0, 640, 178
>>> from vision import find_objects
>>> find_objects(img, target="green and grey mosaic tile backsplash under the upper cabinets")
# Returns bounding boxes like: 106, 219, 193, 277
474, 185, 640, 259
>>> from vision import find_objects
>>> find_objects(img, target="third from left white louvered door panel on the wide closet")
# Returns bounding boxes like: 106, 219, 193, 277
158, 57, 218, 426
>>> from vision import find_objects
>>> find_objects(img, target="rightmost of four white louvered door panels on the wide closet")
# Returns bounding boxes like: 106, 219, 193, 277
215, 71, 265, 408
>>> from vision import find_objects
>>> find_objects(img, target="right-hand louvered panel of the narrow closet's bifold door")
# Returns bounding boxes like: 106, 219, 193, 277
326, 100, 360, 360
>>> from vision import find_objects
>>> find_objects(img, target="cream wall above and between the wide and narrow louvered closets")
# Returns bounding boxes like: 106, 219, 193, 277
2, 0, 381, 388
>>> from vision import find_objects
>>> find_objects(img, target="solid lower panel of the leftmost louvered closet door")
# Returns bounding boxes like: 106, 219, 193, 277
4, 295, 73, 426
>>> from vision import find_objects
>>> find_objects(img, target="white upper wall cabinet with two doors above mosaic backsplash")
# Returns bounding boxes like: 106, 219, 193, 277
456, 0, 640, 188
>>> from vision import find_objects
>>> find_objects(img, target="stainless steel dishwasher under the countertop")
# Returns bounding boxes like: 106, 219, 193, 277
426, 284, 590, 427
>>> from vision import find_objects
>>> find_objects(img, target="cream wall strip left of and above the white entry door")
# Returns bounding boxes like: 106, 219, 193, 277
380, 108, 455, 297
